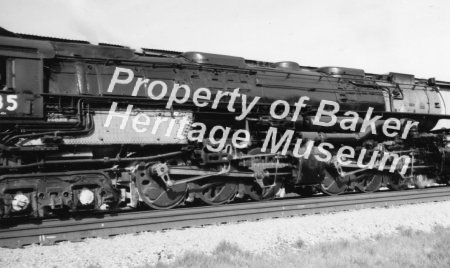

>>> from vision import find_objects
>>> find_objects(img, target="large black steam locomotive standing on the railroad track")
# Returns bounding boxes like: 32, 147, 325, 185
0, 29, 450, 218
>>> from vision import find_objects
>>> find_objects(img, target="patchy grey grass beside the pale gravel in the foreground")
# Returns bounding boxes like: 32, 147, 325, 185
148, 227, 450, 268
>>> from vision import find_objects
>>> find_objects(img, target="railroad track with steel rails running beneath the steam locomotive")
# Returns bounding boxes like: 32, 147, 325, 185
0, 187, 450, 248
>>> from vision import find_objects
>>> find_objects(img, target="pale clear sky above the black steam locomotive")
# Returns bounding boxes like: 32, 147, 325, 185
0, 0, 450, 81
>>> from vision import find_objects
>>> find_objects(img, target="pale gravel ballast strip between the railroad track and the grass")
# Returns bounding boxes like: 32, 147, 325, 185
0, 201, 450, 267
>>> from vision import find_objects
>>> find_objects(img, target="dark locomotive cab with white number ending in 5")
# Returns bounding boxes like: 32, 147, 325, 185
0, 32, 55, 118
